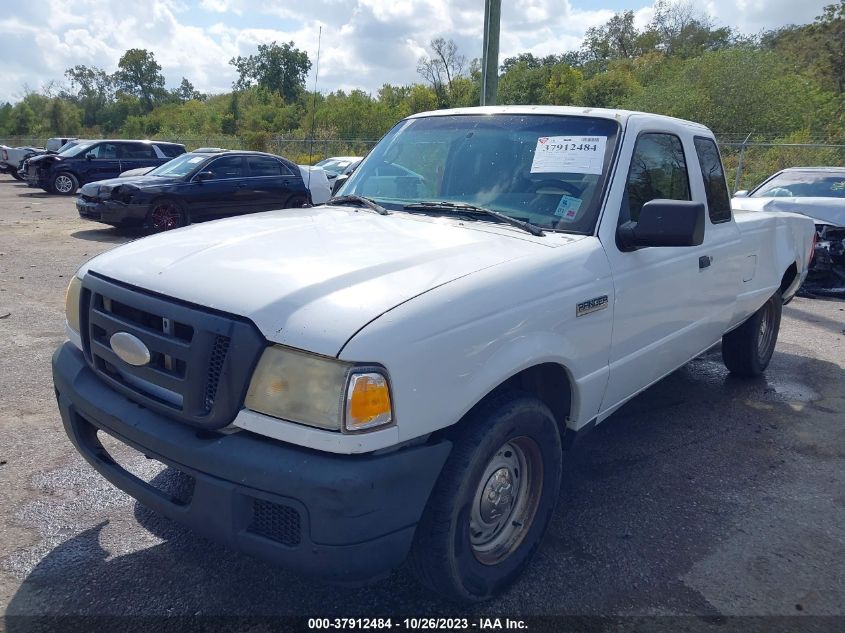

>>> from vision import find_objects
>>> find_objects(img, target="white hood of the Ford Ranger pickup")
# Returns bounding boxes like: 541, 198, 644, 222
84, 207, 568, 360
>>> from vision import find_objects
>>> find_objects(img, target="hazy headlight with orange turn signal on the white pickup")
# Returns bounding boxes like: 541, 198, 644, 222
245, 346, 393, 431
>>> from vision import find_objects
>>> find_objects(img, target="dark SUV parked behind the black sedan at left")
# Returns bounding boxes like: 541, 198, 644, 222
26, 140, 185, 195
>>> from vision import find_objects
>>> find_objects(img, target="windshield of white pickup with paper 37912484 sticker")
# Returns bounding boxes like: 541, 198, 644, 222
338, 114, 619, 233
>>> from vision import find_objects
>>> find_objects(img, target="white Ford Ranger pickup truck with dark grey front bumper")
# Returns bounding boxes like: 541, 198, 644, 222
53, 106, 813, 601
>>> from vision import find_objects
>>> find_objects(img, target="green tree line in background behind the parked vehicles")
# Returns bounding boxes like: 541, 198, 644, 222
0, 0, 845, 163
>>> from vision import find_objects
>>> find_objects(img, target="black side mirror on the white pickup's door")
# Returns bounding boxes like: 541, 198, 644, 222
616, 200, 704, 252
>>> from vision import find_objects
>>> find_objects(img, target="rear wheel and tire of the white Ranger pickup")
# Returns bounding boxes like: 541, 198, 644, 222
722, 292, 783, 378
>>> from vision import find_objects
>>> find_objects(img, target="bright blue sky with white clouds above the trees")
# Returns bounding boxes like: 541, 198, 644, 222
0, 0, 833, 102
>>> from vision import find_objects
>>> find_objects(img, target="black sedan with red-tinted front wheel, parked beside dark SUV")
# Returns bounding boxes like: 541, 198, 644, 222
76, 151, 310, 233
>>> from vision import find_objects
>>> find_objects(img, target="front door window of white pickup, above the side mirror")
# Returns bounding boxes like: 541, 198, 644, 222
619, 133, 690, 224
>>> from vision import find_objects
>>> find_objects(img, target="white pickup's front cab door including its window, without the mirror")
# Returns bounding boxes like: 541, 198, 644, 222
600, 116, 727, 413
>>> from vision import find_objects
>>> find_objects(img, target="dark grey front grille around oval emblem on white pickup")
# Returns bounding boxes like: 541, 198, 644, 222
80, 272, 265, 428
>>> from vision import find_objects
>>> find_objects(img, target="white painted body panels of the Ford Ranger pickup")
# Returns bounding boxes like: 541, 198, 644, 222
74, 106, 813, 453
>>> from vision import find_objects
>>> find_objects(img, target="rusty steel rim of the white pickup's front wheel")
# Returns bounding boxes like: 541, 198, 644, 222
469, 436, 543, 565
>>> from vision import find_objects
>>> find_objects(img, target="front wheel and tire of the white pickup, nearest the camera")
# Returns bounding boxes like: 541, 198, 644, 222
411, 391, 562, 602
